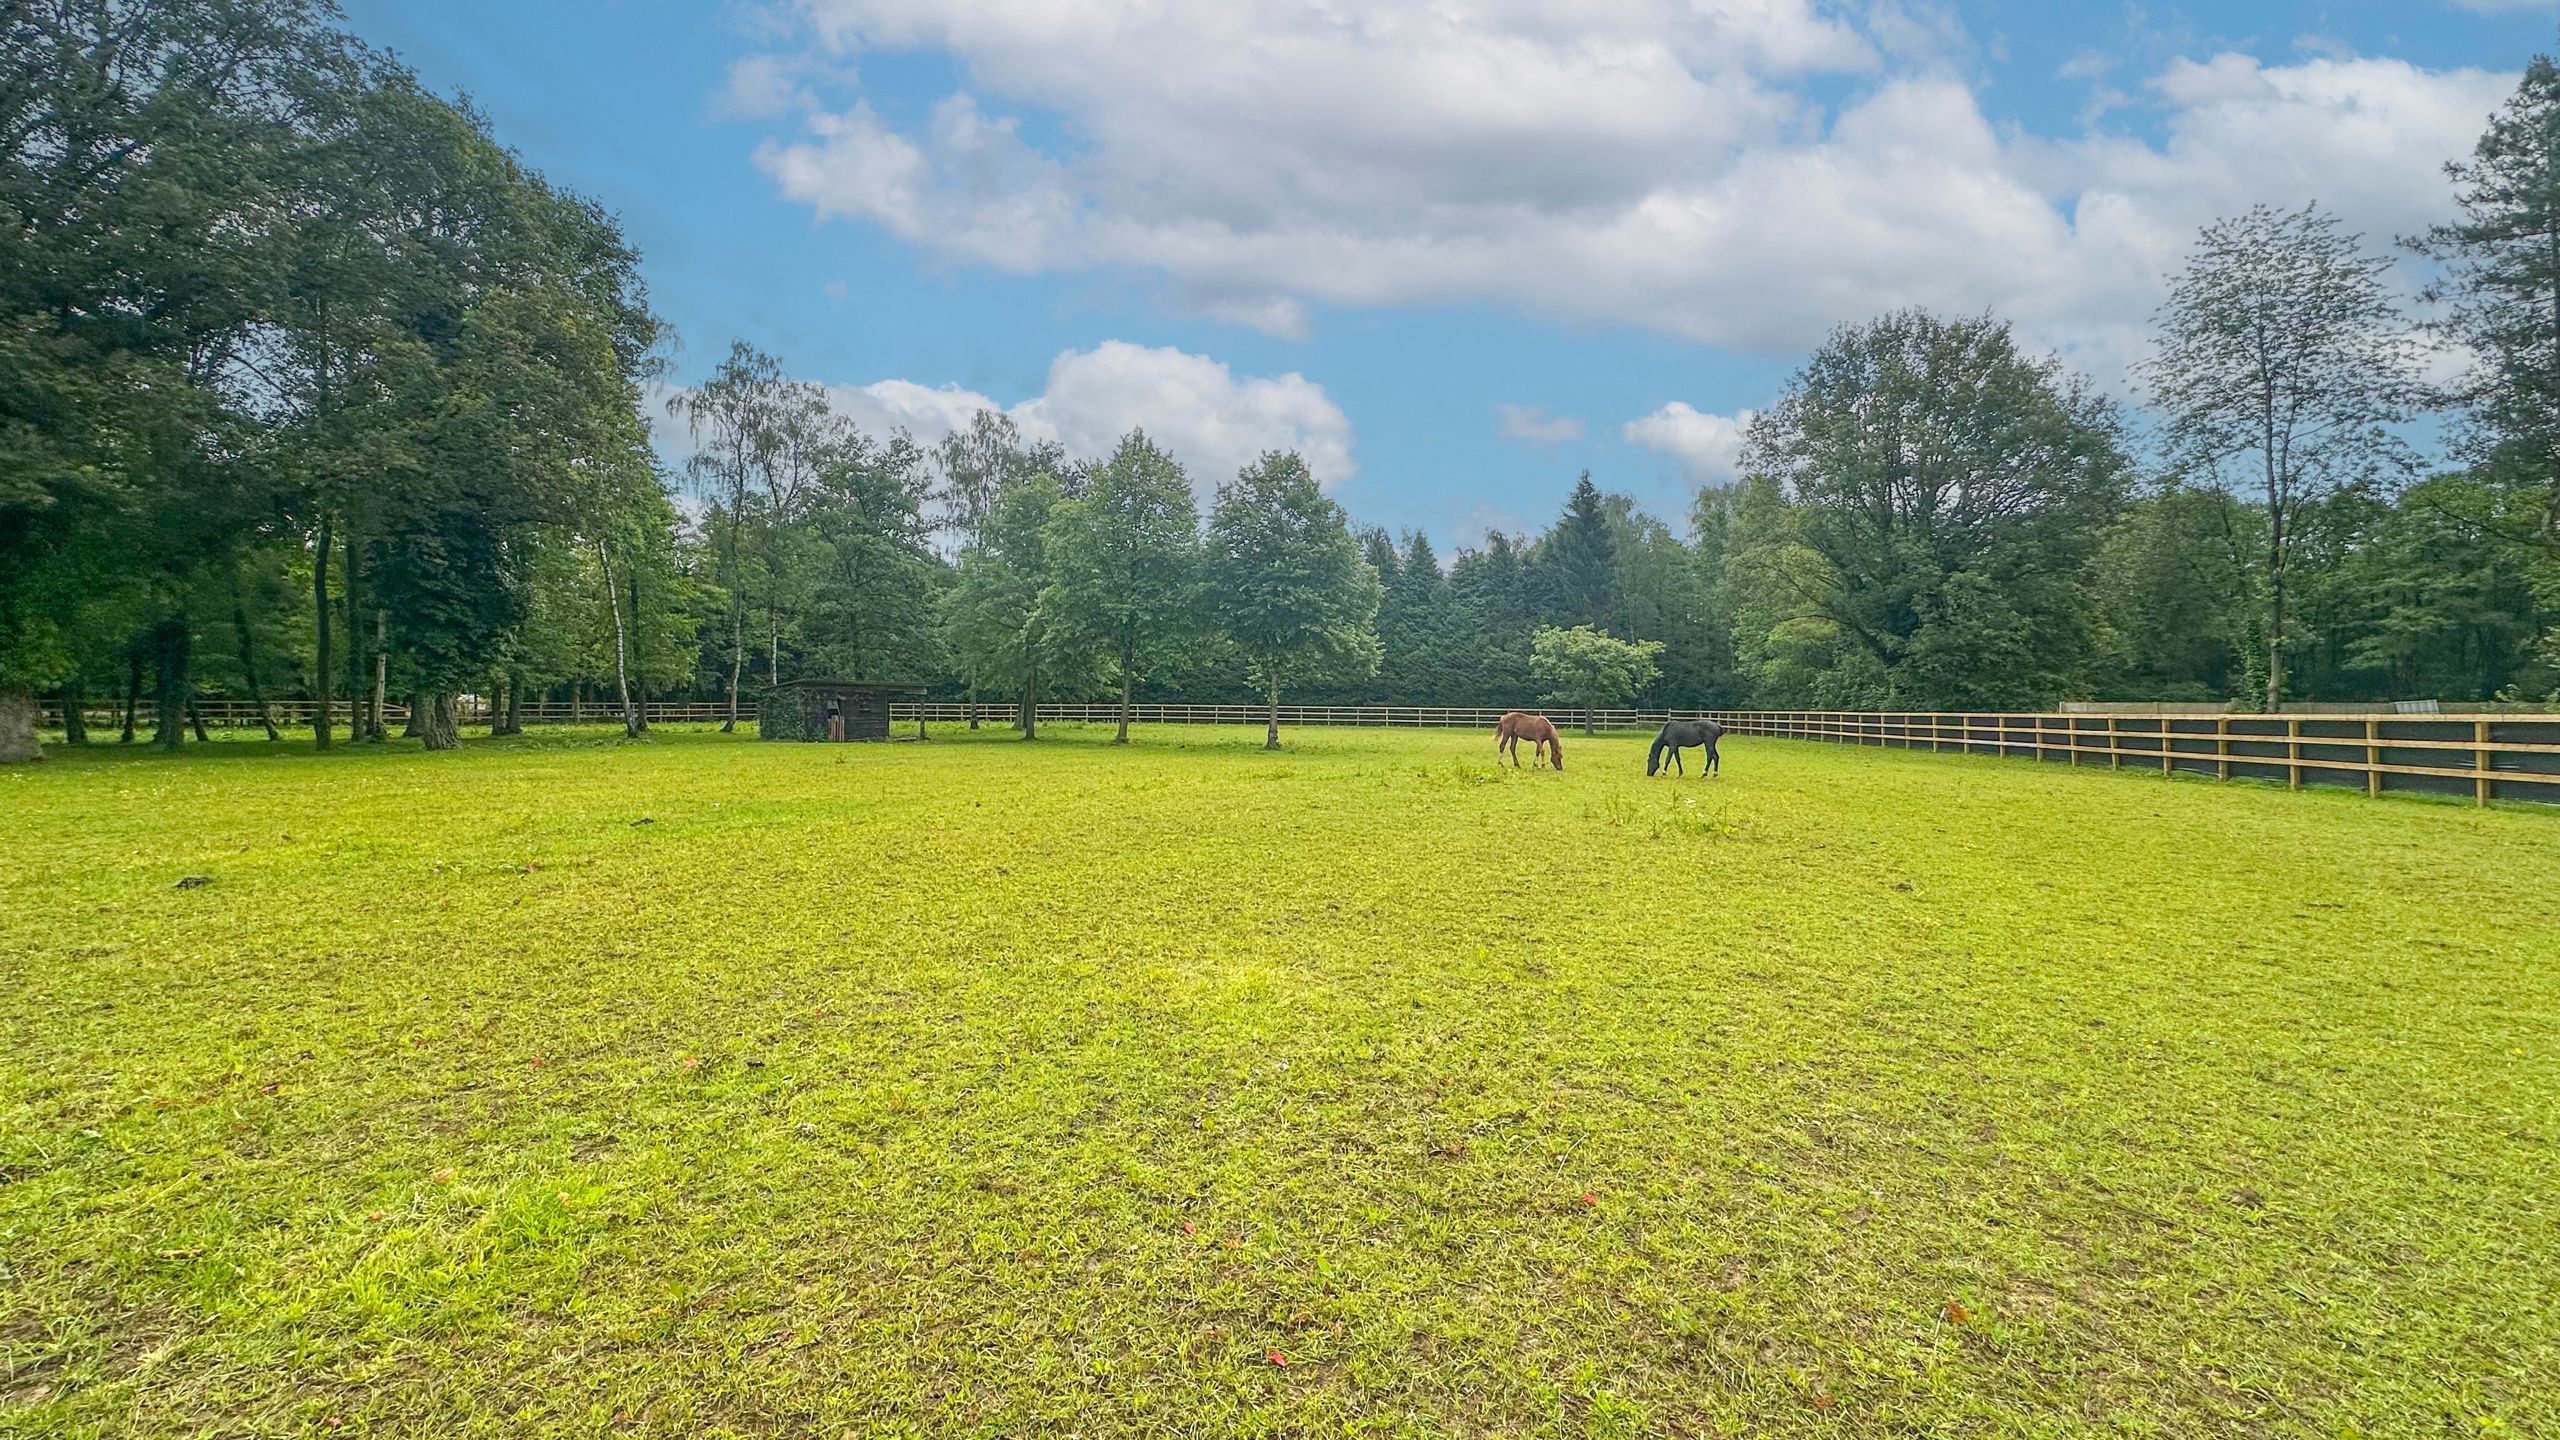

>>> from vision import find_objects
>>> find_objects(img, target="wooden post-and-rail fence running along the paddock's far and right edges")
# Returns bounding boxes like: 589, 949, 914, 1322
46, 700, 2560, 805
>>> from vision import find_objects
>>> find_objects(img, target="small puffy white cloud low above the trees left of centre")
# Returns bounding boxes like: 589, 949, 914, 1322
827, 341, 1359, 495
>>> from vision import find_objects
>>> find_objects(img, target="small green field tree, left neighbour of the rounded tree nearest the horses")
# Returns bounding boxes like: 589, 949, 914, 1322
1039, 430, 1201, 746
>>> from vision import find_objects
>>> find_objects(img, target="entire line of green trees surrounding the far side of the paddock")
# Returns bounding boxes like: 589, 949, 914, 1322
0, 0, 2560, 756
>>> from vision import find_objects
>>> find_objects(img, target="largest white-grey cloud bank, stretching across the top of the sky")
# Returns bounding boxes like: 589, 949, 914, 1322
732, 0, 2511, 368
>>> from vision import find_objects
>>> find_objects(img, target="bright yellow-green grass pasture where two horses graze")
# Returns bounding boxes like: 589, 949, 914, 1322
0, 728, 2560, 1437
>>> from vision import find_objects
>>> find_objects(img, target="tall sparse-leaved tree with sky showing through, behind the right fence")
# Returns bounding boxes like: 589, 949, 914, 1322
2140, 205, 2417, 710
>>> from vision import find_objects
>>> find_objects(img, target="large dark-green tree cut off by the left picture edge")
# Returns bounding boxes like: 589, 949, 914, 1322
0, 0, 364, 761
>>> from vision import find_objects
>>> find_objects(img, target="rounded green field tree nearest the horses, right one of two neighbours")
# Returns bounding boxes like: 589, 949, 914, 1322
1203, 451, 1380, 751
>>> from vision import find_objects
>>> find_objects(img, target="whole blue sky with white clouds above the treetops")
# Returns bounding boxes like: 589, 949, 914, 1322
348, 0, 2560, 548
